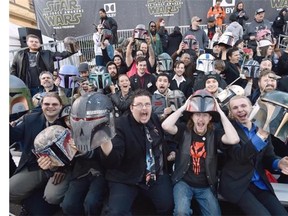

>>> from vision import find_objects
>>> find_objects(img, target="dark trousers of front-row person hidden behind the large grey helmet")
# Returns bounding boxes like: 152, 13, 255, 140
61, 174, 107, 215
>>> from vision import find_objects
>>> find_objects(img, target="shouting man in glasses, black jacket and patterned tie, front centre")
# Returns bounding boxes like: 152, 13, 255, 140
101, 89, 173, 215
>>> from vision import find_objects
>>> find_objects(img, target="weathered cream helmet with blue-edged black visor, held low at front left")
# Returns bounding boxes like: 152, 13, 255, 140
34, 125, 77, 167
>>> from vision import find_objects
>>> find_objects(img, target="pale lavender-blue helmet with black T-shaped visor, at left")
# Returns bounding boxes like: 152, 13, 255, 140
59, 65, 79, 88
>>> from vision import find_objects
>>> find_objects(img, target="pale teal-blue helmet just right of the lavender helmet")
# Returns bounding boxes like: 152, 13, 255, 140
89, 66, 112, 90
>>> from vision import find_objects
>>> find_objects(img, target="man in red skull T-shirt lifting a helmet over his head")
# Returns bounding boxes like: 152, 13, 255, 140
162, 90, 239, 215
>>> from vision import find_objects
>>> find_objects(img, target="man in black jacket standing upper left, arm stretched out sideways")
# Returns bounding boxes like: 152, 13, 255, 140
10, 34, 74, 97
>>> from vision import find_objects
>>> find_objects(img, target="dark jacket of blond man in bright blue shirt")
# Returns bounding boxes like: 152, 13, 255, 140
219, 121, 279, 203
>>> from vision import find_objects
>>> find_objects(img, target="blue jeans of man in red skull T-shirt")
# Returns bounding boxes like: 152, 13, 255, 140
173, 181, 221, 216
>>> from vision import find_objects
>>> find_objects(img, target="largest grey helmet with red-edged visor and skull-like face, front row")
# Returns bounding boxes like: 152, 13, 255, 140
70, 92, 115, 153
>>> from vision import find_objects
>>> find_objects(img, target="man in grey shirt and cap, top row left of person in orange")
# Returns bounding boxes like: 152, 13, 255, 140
183, 16, 209, 49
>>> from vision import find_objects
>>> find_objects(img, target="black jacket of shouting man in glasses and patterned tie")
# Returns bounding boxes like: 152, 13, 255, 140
102, 114, 166, 185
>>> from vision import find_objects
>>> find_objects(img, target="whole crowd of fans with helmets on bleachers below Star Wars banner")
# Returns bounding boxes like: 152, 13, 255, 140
9, 0, 288, 215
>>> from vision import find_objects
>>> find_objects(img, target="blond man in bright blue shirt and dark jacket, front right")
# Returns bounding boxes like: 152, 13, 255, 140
219, 96, 288, 215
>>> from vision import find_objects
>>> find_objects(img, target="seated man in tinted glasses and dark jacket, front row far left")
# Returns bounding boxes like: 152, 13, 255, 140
9, 92, 65, 215
